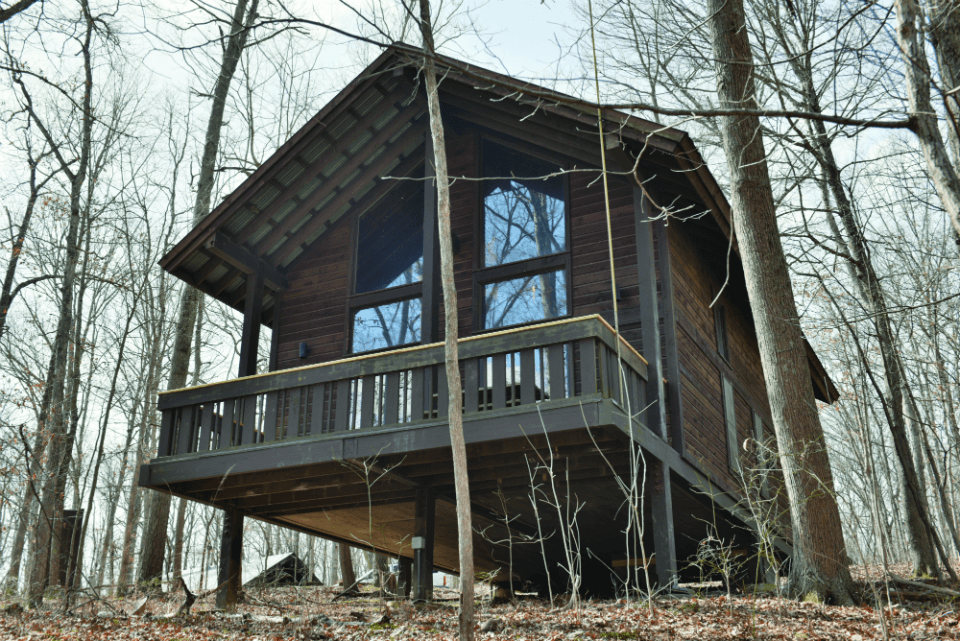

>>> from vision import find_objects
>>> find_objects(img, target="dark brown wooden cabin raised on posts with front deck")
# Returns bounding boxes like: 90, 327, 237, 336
140, 49, 835, 598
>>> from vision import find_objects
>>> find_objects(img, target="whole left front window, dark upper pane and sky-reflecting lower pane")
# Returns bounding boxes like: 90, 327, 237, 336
350, 181, 423, 353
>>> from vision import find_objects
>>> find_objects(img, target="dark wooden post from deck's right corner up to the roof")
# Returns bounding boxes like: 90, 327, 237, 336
633, 187, 667, 438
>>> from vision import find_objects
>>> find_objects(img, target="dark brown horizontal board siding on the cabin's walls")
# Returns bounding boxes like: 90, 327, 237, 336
277, 115, 771, 498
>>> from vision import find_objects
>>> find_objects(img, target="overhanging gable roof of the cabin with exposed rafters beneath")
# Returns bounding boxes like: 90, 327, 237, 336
160, 43, 836, 399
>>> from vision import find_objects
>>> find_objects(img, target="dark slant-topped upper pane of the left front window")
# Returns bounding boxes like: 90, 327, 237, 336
356, 181, 423, 294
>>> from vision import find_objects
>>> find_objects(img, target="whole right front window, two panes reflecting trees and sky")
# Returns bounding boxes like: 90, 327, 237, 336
476, 141, 570, 329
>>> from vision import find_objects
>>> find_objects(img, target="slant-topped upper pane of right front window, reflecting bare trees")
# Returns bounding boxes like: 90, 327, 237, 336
483, 141, 567, 267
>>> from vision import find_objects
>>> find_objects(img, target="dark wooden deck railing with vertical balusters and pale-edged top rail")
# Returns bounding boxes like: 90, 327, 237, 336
157, 316, 647, 457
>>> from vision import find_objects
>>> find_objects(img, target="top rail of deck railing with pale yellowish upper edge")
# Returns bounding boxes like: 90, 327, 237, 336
158, 314, 648, 409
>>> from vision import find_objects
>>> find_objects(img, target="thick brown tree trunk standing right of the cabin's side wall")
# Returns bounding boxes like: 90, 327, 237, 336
705, 0, 853, 604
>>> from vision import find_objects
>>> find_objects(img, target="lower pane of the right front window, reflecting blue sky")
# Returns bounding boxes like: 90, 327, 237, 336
483, 269, 567, 329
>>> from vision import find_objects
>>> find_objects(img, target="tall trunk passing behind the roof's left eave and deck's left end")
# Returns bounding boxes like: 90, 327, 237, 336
139, 0, 259, 582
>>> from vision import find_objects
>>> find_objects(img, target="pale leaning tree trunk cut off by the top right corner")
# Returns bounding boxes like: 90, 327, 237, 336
896, 0, 960, 237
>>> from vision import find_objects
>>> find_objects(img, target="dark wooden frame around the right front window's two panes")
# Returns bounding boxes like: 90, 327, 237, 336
471, 134, 573, 334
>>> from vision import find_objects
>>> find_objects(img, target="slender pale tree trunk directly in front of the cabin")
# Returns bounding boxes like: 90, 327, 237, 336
420, 0, 474, 641
